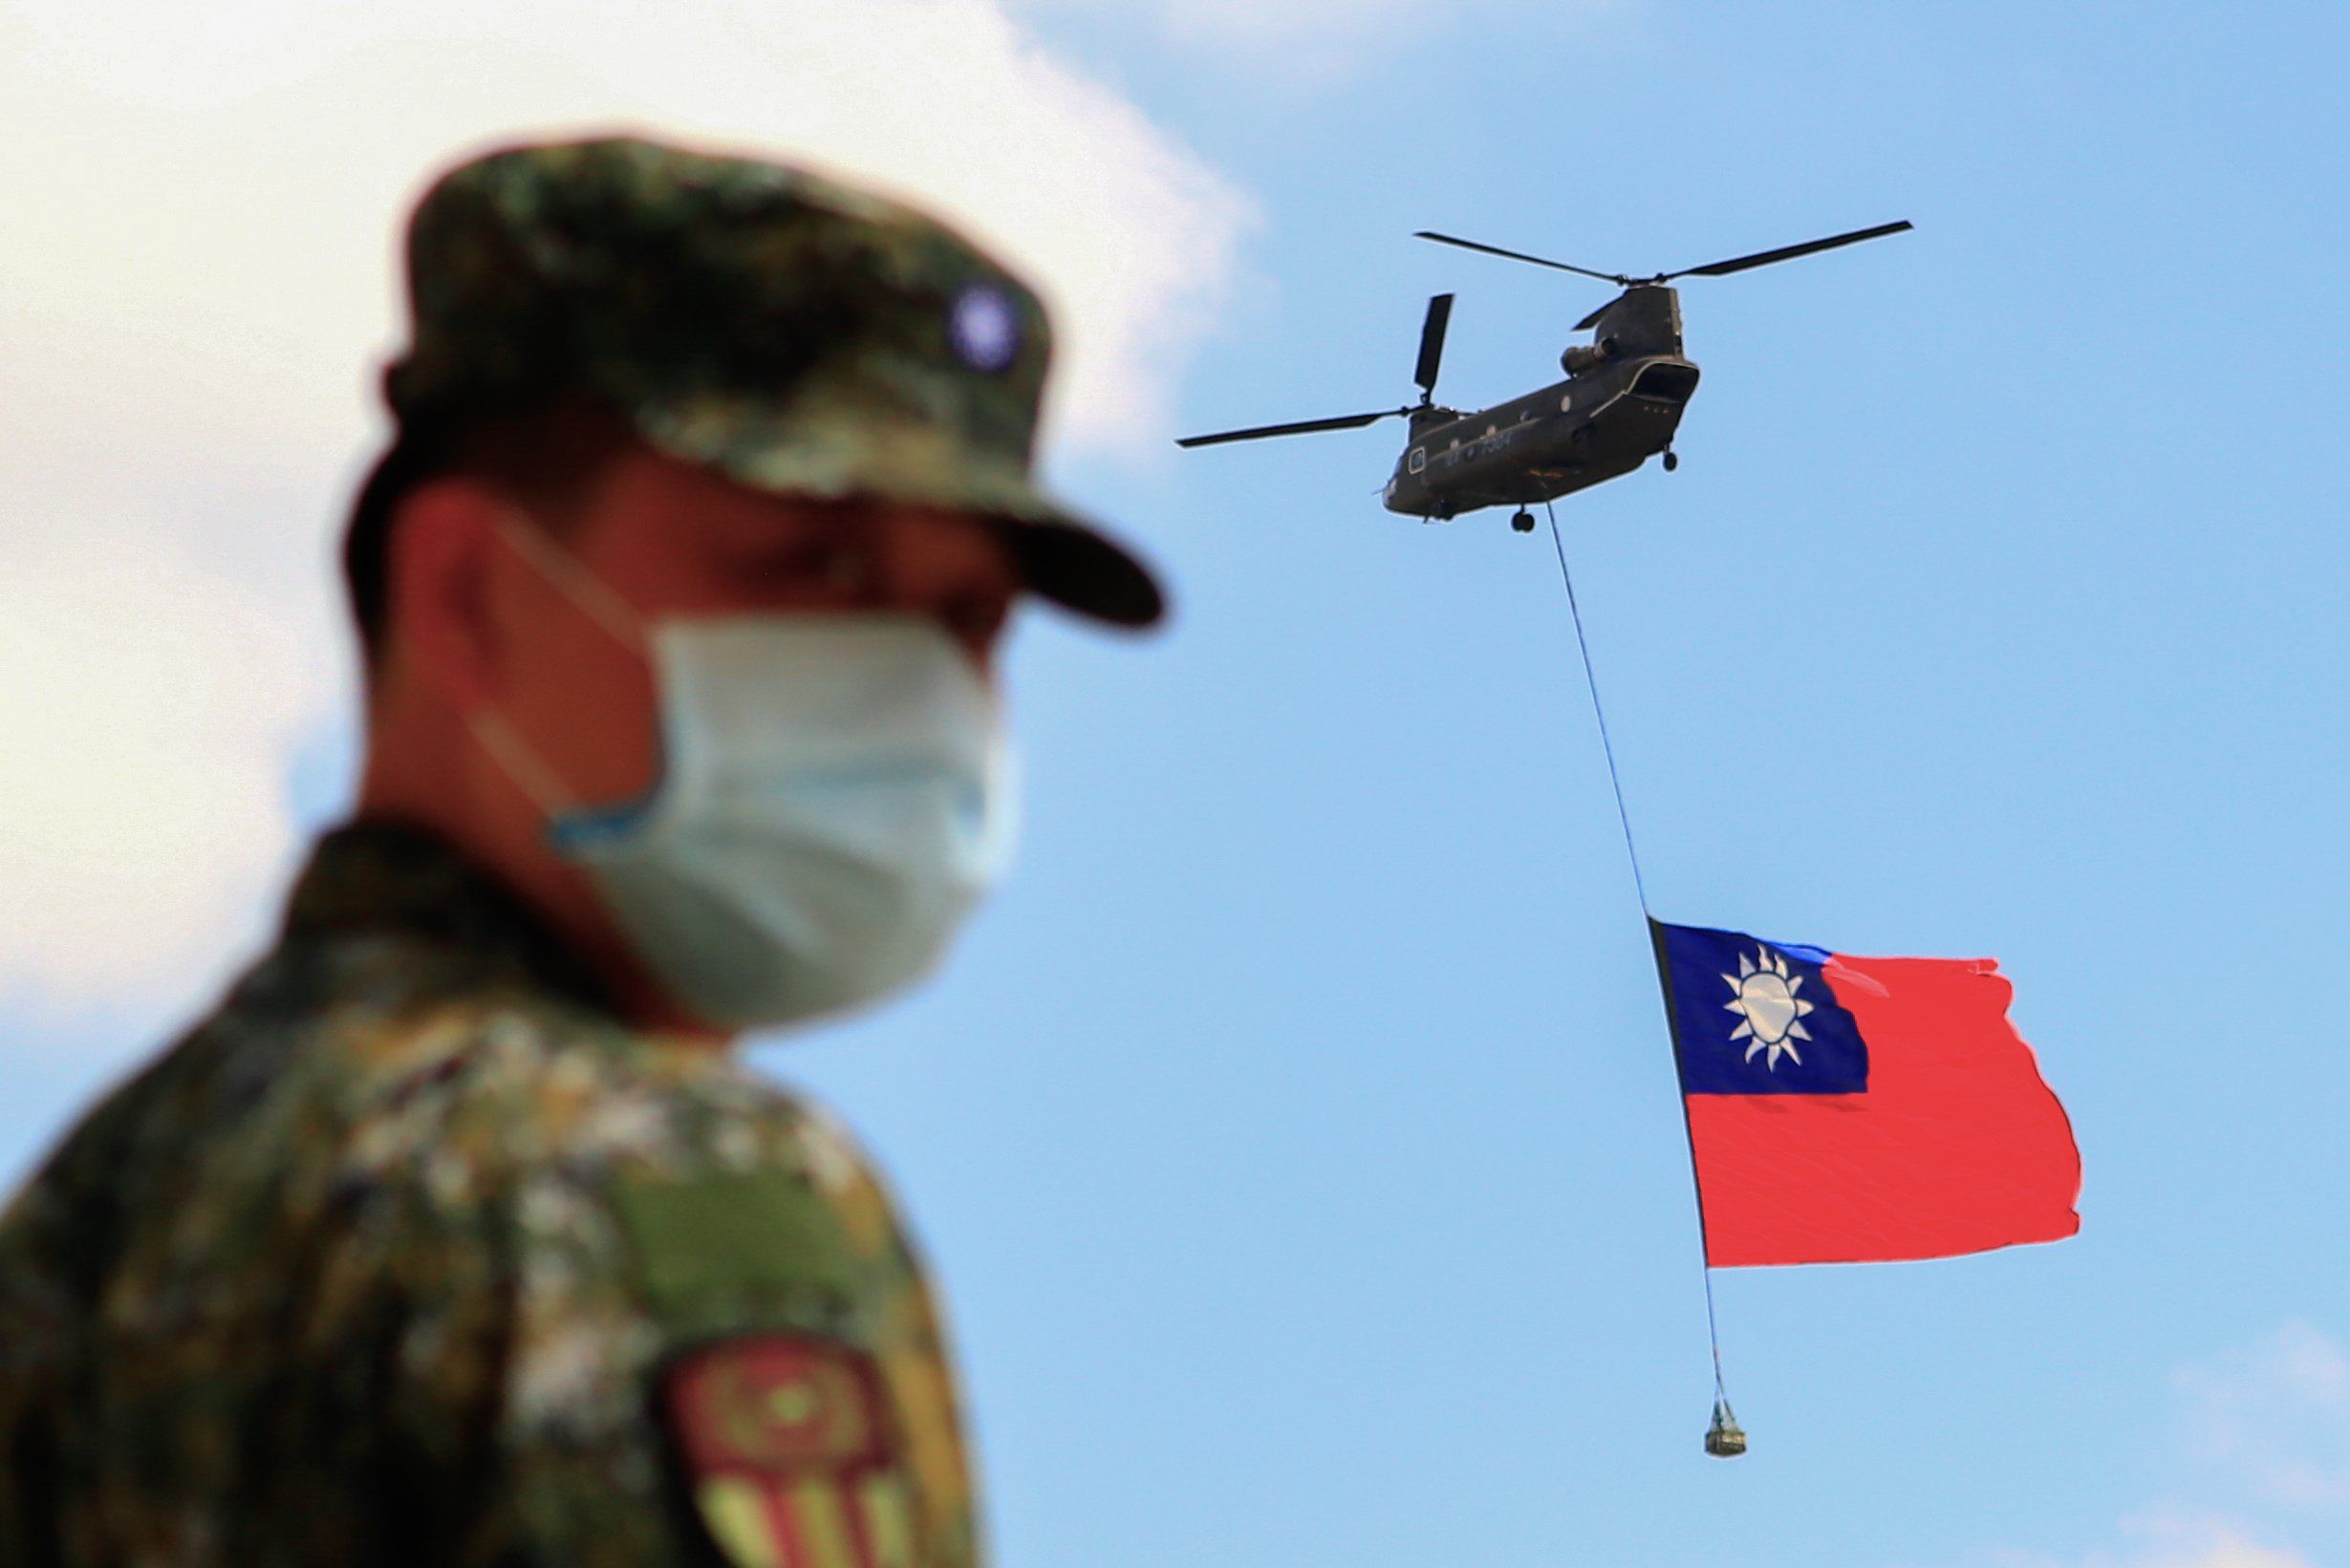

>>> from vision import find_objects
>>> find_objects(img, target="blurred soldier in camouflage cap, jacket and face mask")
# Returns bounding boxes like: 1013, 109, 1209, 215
0, 139, 1161, 1568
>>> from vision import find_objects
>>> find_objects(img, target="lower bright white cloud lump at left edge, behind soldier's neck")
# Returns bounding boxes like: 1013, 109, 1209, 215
0, 541, 327, 1029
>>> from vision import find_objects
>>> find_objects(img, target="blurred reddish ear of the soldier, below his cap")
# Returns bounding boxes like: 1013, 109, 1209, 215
385, 477, 507, 712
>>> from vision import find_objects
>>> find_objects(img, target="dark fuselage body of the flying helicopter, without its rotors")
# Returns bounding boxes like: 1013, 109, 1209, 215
1382, 355, 1696, 520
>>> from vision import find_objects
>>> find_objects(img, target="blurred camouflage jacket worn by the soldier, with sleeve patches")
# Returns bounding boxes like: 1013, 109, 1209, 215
0, 826, 980, 1568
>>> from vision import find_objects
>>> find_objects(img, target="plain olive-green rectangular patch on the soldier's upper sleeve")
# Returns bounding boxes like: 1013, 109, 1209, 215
611, 1169, 858, 1317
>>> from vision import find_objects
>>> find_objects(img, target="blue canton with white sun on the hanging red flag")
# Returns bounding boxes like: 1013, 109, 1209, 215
1649, 919, 1868, 1095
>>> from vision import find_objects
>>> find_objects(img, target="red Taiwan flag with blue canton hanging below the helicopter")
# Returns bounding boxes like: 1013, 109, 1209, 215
1649, 919, 2080, 1267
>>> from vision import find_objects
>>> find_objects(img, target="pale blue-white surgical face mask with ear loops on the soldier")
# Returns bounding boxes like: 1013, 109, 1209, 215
472, 525, 1013, 1027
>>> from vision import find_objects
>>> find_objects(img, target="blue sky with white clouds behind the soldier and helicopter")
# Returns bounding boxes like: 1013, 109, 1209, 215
0, 0, 2350, 1568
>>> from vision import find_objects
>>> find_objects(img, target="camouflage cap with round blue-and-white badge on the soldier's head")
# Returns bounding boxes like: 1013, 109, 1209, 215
383, 137, 1163, 625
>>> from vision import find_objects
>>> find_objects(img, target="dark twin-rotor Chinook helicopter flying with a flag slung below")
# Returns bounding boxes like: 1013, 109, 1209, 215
1175, 219, 1910, 533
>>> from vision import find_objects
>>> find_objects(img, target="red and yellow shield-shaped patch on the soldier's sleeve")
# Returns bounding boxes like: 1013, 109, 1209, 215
662, 1333, 918, 1568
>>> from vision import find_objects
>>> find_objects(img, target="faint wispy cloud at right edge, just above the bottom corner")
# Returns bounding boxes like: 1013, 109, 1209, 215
2178, 1323, 2350, 1509
